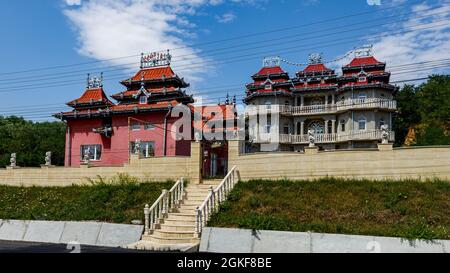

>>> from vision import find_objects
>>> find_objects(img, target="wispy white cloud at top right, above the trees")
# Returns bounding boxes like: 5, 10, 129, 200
339, 3, 450, 81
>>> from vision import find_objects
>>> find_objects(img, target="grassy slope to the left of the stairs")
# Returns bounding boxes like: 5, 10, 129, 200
0, 175, 174, 223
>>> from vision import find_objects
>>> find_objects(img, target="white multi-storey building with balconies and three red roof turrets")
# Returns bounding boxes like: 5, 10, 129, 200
244, 50, 397, 152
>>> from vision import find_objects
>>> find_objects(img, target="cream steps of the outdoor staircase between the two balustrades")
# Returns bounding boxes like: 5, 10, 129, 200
129, 180, 221, 251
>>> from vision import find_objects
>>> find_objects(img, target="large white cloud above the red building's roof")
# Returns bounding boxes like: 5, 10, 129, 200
63, 0, 255, 81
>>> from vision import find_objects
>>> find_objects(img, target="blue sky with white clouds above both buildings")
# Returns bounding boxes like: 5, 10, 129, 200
0, 0, 450, 121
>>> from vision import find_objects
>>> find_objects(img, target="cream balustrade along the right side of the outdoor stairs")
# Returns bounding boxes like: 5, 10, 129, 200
195, 166, 238, 237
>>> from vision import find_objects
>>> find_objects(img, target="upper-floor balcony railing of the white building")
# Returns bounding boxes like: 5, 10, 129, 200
279, 98, 397, 115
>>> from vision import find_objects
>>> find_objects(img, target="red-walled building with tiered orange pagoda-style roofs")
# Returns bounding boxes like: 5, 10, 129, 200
54, 52, 236, 175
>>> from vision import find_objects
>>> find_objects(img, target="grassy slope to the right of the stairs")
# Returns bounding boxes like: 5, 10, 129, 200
208, 178, 450, 240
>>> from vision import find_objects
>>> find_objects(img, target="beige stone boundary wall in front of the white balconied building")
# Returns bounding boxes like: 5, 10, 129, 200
228, 141, 450, 180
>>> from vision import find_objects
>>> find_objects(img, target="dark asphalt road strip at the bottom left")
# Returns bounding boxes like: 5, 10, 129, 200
0, 240, 148, 253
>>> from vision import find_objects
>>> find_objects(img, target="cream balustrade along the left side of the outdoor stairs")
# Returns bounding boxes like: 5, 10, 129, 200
144, 178, 184, 235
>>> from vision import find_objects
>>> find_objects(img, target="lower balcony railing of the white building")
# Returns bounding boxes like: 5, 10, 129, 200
279, 130, 395, 144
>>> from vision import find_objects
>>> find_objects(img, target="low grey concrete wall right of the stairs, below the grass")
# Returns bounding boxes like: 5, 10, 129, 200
200, 227, 450, 253
